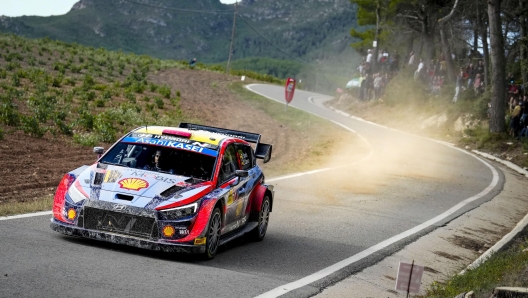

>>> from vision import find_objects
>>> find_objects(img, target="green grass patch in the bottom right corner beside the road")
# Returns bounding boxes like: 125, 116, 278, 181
424, 238, 528, 298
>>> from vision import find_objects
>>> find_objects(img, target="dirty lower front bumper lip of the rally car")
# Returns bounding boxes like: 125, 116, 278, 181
50, 218, 205, 253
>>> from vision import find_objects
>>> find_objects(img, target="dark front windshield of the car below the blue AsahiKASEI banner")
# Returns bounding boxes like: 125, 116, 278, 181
100, 142, 216, 180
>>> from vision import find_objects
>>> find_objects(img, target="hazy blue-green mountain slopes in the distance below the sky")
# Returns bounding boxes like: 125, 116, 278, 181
0, 0, 357, 63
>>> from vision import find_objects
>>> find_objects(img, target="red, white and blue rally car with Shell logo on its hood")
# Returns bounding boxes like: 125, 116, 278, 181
51, 123, 274, 259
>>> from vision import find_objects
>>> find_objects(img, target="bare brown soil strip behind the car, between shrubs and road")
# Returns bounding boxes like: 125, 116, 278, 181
0, 69, 361, 204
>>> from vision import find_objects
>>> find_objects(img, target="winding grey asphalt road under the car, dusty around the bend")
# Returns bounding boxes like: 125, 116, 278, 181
0, 85, 504, 298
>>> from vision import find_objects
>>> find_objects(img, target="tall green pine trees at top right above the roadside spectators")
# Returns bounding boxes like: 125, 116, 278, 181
351, 0, 528, 133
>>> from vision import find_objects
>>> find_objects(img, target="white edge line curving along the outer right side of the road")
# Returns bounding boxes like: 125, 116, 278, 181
246, 85, 499, 298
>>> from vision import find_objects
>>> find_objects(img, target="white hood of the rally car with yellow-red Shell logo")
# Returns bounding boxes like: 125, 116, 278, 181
74, 164, 212, 209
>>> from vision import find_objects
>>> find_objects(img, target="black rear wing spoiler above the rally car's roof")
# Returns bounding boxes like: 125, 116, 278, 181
179, 122, 273, 163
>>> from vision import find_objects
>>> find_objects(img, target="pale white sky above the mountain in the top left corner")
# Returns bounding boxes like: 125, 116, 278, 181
0, 0, 236, 17
